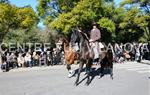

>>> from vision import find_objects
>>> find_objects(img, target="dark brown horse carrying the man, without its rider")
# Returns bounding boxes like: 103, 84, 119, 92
71, 30, 113, 85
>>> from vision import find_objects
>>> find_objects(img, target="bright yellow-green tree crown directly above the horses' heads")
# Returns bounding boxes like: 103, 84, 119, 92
48, 0, 101, 33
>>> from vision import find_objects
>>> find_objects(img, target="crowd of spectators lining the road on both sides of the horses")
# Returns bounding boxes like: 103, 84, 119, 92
0, 43, 150, 71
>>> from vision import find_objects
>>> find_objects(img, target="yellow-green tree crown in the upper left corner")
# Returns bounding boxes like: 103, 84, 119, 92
0, 3, 38, 42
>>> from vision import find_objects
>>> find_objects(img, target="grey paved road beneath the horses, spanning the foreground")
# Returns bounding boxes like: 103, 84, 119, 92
0, 62, 150, 95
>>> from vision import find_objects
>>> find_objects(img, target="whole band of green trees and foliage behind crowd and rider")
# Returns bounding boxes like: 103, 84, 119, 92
0, 0, 150, 44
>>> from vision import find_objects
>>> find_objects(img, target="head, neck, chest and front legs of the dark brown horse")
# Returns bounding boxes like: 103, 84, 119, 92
70, 30, 94, 86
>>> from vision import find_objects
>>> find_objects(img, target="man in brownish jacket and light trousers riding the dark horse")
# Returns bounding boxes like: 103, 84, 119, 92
89, 23, 101, 61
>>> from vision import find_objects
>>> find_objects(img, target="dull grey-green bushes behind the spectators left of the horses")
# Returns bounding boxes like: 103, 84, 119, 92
3, 27, 59, 47
